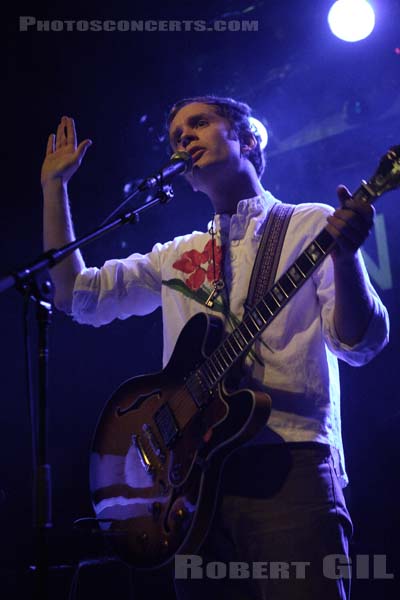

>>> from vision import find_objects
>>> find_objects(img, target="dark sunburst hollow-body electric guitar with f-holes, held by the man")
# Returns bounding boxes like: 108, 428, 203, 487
90, 146, 400, 569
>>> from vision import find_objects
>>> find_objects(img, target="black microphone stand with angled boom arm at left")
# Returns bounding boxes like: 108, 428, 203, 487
0, 184, 173, 600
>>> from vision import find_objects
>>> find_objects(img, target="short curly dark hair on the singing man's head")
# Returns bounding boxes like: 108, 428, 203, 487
166, 94, 265, 178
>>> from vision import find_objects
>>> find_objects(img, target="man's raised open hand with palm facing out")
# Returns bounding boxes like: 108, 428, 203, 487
41, 117, 92, 186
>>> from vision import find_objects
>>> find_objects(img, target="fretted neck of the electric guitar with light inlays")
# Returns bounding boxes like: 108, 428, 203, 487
197, 181, 379, 390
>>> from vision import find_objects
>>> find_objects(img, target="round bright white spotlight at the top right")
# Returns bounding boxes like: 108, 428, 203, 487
328, 0, 375, 42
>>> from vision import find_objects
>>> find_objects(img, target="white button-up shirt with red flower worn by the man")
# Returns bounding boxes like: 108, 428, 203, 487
72, 192, 389, 485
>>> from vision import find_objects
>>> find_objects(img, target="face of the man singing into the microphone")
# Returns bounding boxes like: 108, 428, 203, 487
169, 102, 240, 189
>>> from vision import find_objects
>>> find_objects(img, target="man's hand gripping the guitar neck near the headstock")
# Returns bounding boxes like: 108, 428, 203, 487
328, 185, 375, 261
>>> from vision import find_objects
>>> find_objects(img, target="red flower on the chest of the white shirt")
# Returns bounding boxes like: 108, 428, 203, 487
172, 240, 222, 290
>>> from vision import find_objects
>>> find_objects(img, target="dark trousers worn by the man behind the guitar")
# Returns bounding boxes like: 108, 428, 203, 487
174, 442, 353, 600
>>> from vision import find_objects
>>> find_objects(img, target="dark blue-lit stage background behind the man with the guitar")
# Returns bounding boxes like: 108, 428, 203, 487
0, 0, 400, 598
